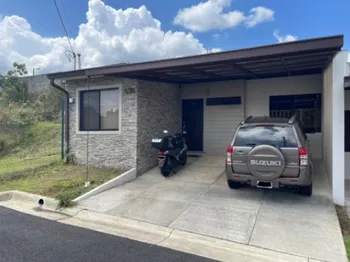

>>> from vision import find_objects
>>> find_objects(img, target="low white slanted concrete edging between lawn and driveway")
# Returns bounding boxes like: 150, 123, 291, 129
73, 168, 136, 202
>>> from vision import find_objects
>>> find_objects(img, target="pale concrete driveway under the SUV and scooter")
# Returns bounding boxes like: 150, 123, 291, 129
80, 156, 346, 261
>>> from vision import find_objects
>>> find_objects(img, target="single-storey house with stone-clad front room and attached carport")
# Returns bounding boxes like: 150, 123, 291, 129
48, 36, 350, 205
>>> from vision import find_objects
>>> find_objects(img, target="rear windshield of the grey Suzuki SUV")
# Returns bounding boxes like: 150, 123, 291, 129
234, 125, 298, 147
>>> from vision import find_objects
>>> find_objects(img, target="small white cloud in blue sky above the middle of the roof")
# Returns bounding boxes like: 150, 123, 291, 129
174, 0, 274, 32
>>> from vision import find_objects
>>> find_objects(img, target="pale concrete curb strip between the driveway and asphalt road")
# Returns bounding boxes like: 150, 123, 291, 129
60, 210, 306, 262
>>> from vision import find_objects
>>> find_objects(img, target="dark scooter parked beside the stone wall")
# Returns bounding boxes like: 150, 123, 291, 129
152, 130, 187, 177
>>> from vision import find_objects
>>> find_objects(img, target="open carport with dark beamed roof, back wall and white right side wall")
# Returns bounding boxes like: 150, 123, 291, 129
82, 36, 347, 205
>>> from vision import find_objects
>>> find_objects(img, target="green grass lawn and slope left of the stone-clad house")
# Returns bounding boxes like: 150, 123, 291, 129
0, 122, 121, 206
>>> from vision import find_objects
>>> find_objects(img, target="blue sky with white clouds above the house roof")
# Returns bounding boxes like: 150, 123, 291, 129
0, 0, 350, 73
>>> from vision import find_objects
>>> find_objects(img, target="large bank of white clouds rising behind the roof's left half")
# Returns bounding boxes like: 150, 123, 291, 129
0, 0, 217, 73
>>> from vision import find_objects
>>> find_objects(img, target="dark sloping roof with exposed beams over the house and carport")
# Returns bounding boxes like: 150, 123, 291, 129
48, 35, 344, 84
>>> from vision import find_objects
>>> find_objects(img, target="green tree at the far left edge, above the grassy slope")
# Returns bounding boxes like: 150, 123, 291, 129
0, 63, 28, 102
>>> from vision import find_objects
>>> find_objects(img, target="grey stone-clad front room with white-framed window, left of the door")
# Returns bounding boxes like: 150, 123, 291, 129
65, 77, 181, 173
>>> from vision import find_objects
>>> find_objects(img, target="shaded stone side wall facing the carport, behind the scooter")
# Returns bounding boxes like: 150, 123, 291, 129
137, 81, 181, 174
